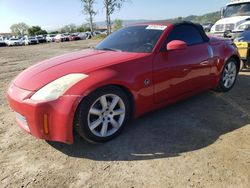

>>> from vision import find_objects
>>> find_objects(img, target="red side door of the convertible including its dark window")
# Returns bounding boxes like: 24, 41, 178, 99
153, 25, 212, 103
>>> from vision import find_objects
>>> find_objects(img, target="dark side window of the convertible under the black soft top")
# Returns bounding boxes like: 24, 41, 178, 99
164, 25, 204, 46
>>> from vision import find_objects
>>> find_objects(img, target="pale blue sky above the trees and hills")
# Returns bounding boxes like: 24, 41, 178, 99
0, 0, 229, 33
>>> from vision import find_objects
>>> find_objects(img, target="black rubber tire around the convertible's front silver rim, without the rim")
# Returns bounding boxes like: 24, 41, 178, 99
75, 86, 130, 143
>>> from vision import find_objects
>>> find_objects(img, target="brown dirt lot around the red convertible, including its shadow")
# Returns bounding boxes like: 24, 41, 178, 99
0, 40, 250, 188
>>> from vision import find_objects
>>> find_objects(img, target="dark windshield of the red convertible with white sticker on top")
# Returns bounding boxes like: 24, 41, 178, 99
96, 26, 166, 53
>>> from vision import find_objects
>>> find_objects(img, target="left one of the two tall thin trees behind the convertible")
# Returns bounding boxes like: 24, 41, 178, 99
81, 0, 97, 34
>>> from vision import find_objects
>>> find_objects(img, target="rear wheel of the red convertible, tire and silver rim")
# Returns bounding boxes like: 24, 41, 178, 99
217, 58, 240, 92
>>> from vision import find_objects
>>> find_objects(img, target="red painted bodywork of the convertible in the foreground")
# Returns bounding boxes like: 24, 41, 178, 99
8, 23, 238, 143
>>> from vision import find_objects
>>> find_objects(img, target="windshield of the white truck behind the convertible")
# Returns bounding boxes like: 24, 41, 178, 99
224, 3, 250, 18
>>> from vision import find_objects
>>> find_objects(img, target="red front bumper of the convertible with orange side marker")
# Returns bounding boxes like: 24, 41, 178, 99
7, 84, 80, 144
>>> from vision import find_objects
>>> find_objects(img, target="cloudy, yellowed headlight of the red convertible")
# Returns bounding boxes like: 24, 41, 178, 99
31, 73, 88, 101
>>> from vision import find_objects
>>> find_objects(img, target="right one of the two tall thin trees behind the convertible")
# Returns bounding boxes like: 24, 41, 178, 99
104, 0, 126, 35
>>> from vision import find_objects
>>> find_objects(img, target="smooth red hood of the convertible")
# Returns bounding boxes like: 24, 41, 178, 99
13, 49, 146, 91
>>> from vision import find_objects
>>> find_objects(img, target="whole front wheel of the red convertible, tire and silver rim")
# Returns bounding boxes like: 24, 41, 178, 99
74, 86, 131, 143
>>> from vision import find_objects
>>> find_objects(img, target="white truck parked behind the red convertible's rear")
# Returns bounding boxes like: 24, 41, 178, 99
211, 0, 250, 37
